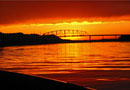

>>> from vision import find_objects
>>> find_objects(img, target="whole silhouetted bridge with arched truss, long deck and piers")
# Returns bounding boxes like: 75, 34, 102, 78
43, 30, 129, 40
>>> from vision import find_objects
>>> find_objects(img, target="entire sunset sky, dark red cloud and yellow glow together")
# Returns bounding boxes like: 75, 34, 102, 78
0, 0, 130, 34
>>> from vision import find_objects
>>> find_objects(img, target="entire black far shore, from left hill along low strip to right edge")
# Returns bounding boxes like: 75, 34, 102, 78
0, 33, 130, 47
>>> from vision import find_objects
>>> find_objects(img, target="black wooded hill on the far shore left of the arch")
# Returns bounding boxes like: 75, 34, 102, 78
0, 32, 64, 46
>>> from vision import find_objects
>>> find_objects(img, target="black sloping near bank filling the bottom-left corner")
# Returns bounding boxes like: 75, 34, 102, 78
0, 71, 90, 90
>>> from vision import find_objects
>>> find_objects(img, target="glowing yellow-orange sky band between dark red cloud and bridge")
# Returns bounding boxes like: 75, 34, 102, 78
0, 21, 130, 34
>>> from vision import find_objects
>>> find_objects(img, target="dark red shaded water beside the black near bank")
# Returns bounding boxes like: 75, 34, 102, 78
36, 70, 130, 90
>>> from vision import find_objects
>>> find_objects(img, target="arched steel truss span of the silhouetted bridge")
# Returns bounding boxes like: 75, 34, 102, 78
43, 30, 89, 37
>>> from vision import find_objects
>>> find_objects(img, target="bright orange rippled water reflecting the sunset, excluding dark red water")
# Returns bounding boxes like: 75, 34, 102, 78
0, 42, 130, 74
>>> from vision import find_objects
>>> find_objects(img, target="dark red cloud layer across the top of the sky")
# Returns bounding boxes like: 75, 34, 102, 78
0, 1, 130, 25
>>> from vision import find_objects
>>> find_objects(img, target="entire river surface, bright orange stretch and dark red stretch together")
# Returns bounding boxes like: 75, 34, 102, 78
0, 42, 130, 90
